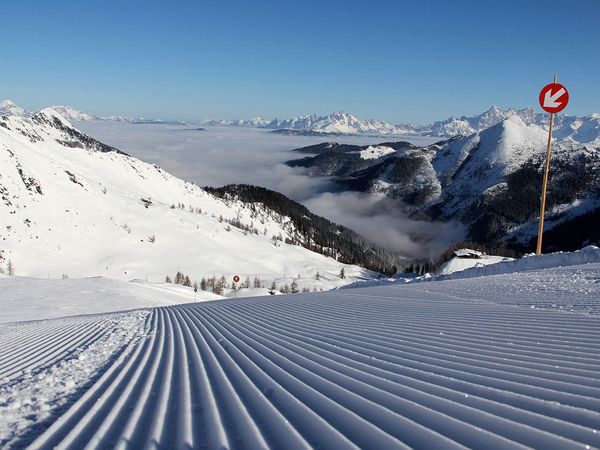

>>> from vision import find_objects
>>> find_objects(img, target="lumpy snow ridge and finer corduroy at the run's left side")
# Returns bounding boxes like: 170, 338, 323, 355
0, 310, 150, 448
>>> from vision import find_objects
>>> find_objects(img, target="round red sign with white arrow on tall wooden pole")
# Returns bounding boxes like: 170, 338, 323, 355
535, 75, 569, 255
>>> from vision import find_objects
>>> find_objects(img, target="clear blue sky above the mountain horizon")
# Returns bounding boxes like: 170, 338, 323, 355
0, 0, 600, 123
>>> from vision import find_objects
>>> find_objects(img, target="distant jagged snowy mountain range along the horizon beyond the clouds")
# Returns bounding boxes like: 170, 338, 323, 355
0, 100, 600, 145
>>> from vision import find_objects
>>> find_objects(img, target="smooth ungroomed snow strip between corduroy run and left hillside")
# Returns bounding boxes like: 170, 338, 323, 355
0, 272, 380, 324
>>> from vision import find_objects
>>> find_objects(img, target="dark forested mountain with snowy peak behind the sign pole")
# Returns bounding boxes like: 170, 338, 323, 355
287, 114, 600, 251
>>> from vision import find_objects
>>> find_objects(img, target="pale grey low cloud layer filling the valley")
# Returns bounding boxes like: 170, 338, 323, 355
77, 122, 463, 258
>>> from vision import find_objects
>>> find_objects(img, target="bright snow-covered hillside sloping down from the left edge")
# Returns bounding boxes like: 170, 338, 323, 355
0, 108, 393, 289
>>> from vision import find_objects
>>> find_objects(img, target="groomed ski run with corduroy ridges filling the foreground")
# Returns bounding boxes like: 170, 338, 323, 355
0, 262, 600, 449
